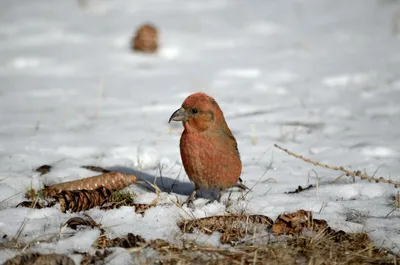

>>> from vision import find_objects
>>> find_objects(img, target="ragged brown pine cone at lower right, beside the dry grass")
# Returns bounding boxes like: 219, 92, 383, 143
272, 210, 330, 235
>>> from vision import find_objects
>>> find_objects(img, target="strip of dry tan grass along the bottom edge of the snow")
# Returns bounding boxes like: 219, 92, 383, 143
95, 228, 400, 265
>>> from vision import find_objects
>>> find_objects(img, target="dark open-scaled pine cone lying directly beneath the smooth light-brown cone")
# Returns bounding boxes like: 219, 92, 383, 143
53, 187, 111, 212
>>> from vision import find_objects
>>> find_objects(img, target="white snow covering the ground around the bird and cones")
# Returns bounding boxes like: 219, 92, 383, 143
0, 0, 400, 264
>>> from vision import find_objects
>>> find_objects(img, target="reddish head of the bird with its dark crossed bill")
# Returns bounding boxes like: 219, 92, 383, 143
169, 92, 226, 132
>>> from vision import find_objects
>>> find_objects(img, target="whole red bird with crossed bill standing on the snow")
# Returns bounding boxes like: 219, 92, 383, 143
169, 93, 242, 205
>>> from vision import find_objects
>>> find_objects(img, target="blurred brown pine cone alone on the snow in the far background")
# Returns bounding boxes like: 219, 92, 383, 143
131, 24, 158, 53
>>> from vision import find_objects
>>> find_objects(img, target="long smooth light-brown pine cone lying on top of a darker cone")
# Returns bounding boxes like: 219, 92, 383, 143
43, 172, 137, 197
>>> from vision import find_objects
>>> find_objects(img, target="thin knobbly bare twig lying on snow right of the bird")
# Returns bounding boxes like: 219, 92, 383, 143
274, 144, 400, 188
